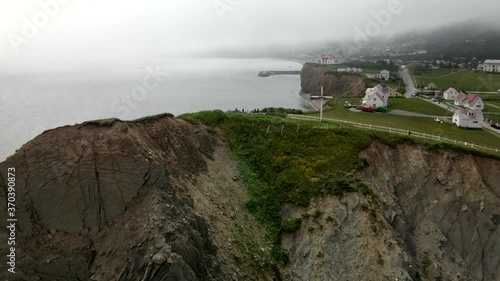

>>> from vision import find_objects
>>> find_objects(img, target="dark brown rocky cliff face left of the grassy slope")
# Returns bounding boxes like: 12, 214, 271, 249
0, 118, 270, 280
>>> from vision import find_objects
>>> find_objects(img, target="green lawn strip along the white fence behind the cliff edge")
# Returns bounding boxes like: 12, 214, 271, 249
308, 98, 500, 148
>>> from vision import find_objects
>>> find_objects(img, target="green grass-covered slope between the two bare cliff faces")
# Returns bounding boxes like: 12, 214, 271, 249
180, 111, 498, 274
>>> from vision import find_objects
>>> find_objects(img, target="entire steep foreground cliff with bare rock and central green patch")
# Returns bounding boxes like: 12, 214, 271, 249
0, 112, 500, 281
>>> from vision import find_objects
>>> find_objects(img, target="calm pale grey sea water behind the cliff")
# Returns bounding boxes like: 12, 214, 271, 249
0, 58, 305, 161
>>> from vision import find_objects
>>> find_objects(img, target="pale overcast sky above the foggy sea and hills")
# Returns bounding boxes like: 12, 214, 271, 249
0, 0, 500, 63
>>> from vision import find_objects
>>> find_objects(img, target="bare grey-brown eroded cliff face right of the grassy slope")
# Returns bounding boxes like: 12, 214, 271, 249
283, 143, 500, 281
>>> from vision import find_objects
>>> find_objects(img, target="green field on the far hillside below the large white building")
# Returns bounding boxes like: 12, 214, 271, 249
414, 69, 500, 92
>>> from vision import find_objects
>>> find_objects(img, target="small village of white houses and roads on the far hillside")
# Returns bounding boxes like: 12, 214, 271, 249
312, 55, 500, 134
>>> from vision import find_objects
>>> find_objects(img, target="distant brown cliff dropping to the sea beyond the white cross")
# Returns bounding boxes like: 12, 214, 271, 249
300, 63, 365, 96
